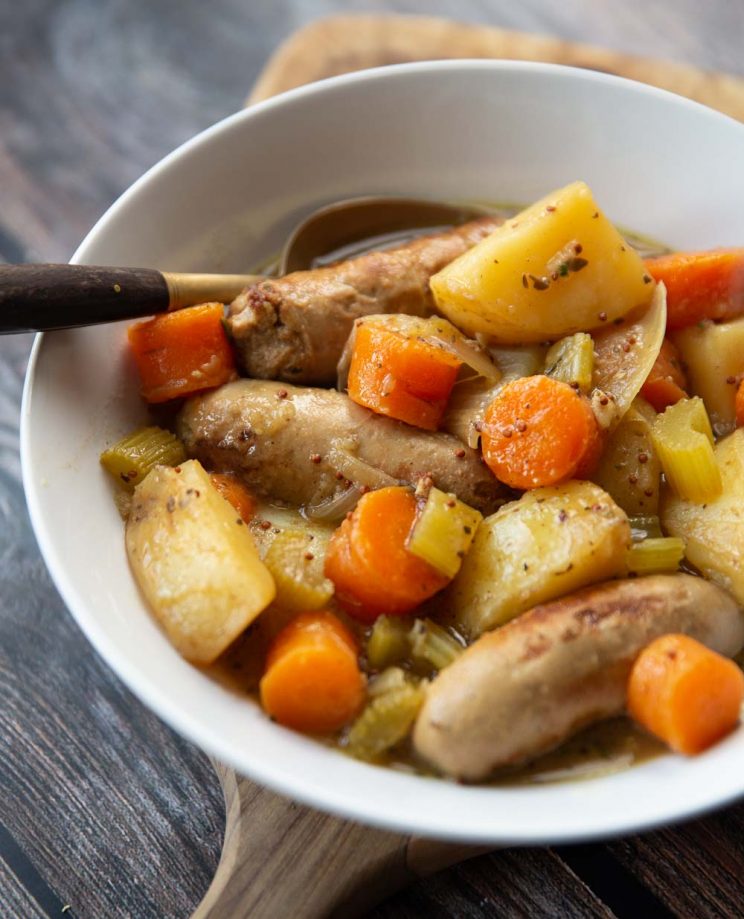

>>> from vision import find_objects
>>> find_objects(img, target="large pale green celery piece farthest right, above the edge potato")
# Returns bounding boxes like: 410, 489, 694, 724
651, 396, 723, 504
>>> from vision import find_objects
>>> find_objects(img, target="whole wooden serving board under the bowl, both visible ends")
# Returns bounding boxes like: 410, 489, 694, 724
194, 15, 744, 919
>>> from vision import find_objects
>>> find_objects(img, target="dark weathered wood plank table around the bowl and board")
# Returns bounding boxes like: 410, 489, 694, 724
0, 0, 744, 919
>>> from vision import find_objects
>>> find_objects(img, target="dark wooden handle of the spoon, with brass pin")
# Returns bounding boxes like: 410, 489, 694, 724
0, 265, 169, 334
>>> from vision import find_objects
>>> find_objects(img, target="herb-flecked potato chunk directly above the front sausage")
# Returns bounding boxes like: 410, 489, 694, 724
449, 481, 630, 638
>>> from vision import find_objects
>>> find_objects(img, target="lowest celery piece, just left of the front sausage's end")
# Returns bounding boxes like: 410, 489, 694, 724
347, 682, 426, 760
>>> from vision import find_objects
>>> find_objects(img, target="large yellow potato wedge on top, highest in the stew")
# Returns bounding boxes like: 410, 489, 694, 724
430, 182, 653, 344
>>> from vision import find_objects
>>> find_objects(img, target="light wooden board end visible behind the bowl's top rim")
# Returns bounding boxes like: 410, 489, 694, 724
248, 15, 744, 121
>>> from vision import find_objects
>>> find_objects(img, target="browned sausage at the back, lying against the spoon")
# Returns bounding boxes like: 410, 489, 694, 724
227, 216, 503, 385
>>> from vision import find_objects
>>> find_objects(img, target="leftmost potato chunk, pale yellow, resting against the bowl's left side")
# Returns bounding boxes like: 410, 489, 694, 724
126, 460, 275, 664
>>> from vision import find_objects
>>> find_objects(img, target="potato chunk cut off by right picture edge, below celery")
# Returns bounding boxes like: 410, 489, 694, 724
660, 428, 744, 605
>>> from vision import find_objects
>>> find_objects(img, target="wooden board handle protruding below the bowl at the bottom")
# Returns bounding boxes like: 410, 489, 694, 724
192, 763, 492, 919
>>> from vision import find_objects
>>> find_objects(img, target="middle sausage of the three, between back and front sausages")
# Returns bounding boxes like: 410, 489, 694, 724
178, 380, 506, 513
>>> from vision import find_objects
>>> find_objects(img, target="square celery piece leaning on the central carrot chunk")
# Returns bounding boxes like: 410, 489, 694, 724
408, 488, 483, 578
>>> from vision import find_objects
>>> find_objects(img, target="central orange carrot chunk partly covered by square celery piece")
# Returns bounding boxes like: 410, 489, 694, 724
325, 486, 449, 622
